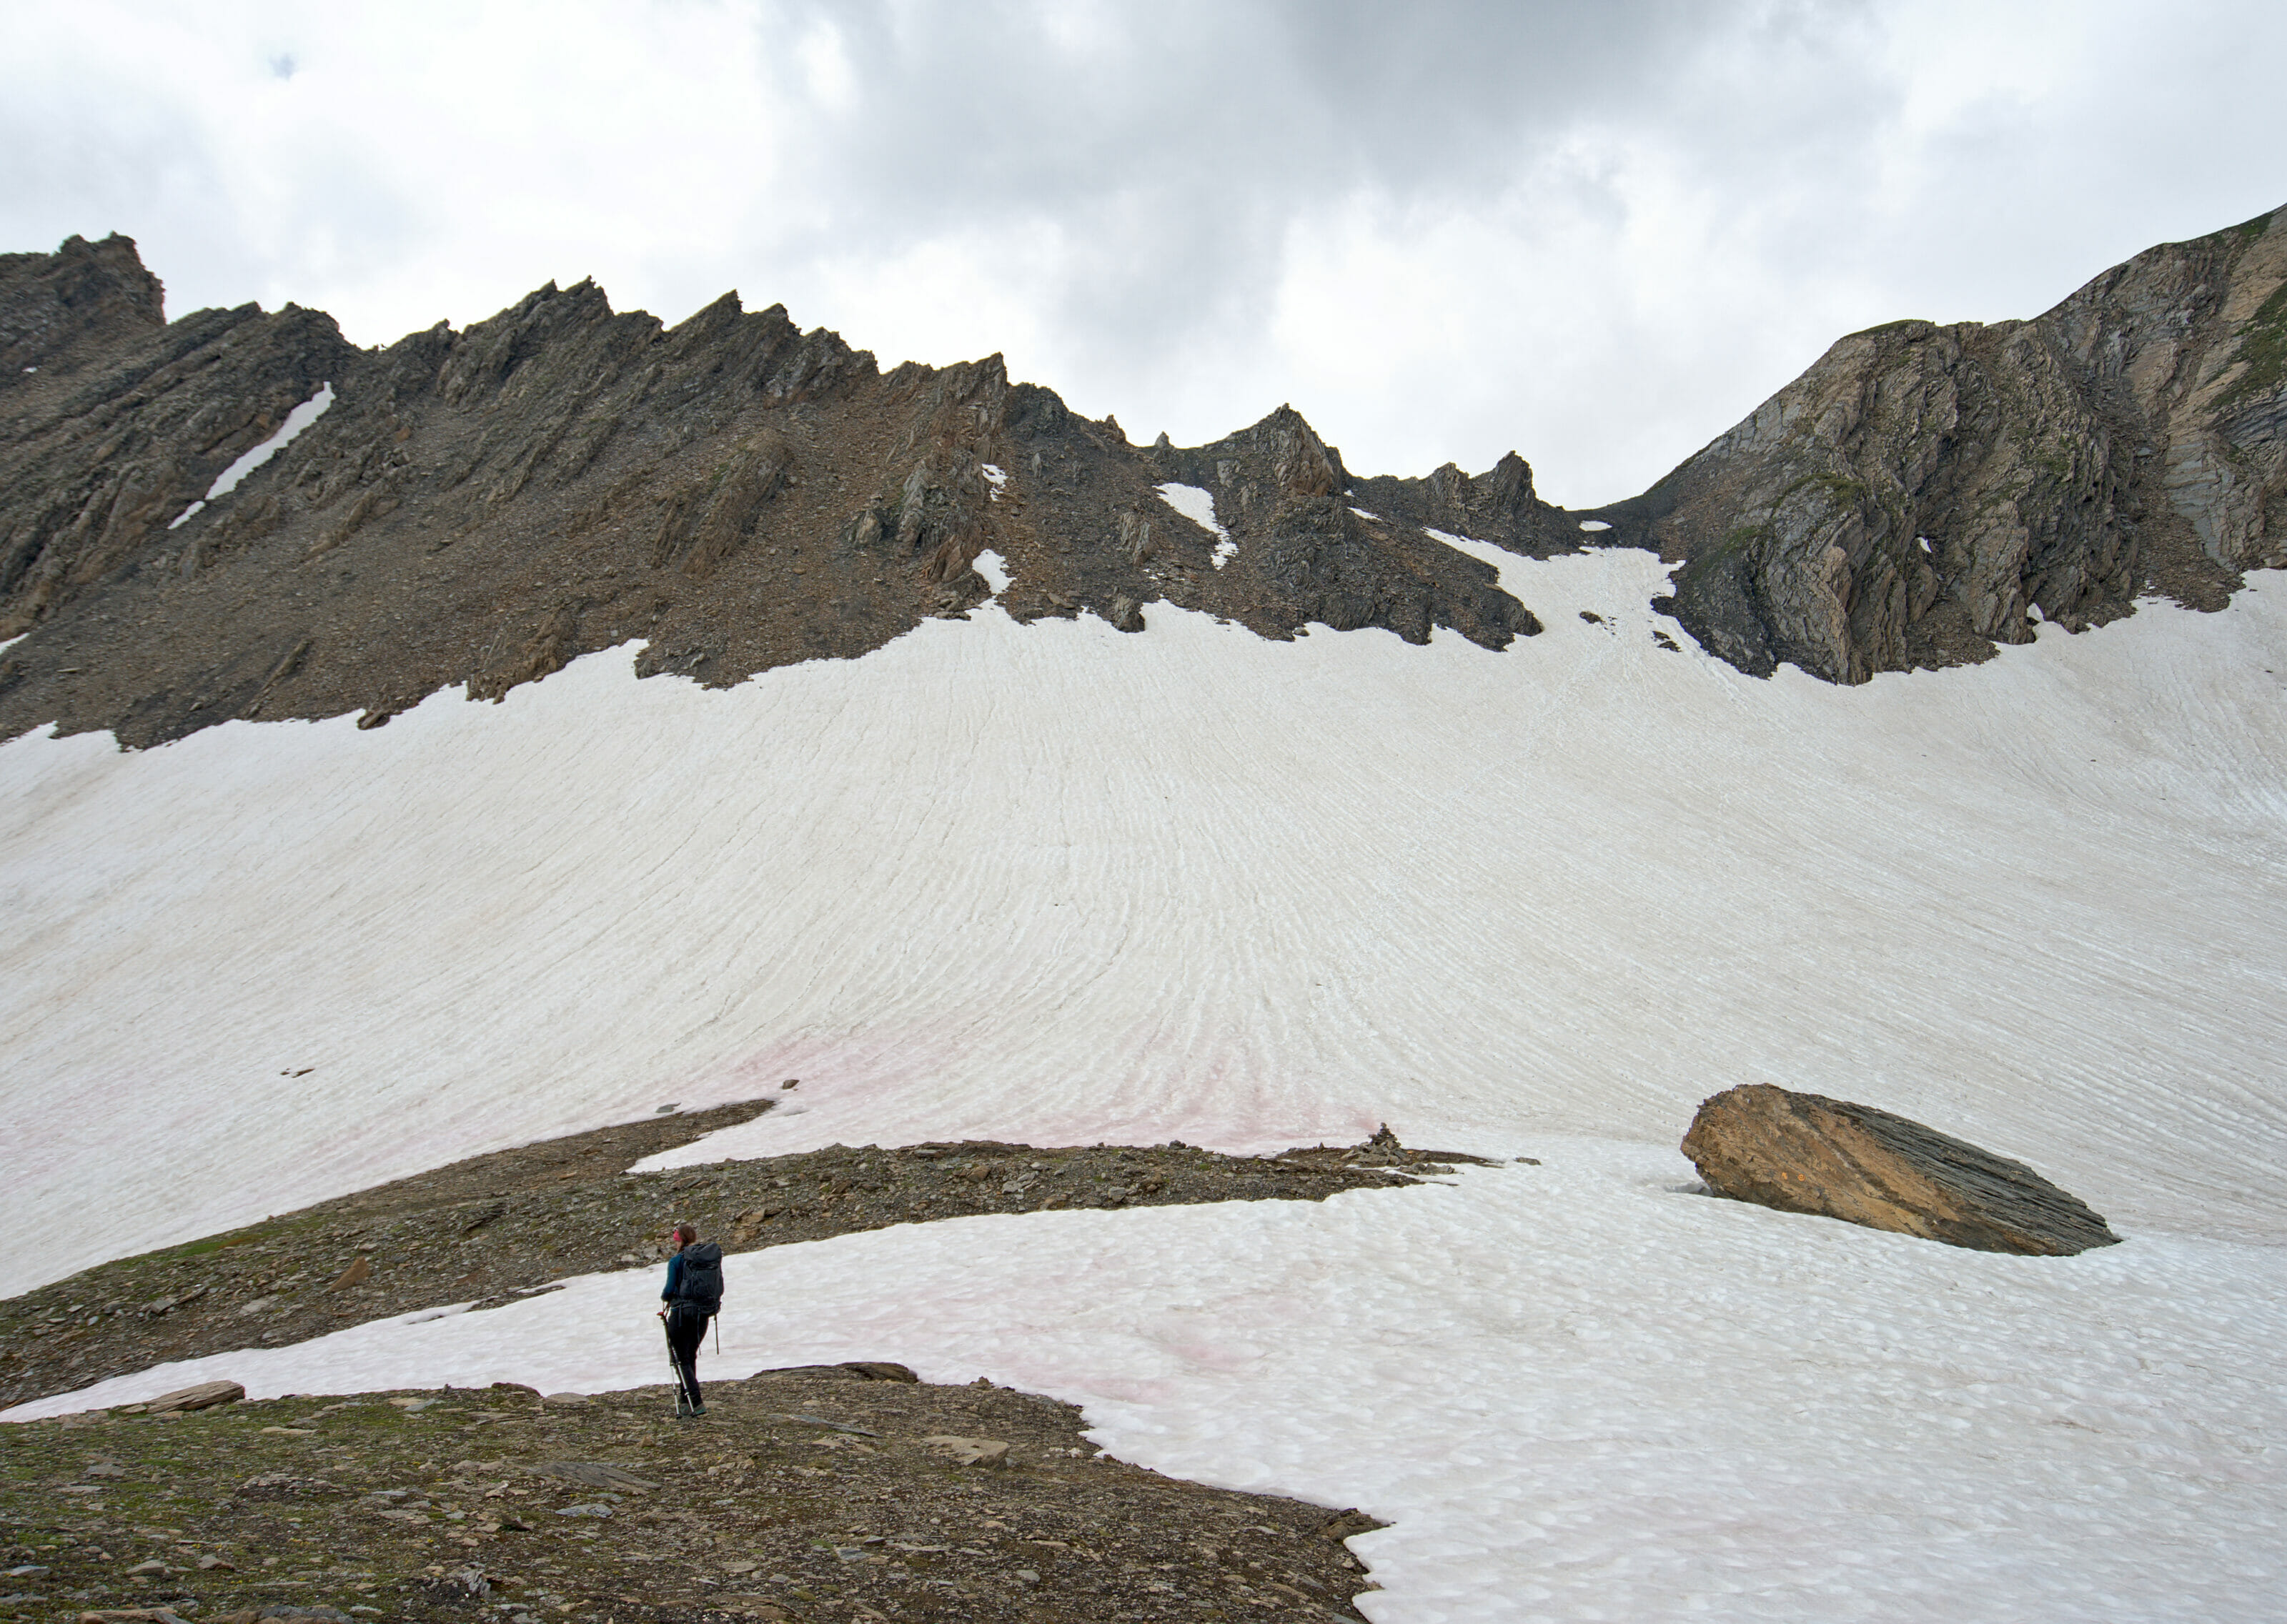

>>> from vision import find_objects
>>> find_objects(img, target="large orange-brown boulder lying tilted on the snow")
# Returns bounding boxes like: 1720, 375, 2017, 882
1683, 1084, 2120, 1258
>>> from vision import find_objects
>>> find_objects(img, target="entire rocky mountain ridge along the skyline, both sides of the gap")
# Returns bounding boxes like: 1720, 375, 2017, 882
0, 211, 2287, 746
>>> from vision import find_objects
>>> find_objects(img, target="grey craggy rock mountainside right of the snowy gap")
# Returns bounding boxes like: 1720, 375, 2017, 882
1599, 211, 2287, 682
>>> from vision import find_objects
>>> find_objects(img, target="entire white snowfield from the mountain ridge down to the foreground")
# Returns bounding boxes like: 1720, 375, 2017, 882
0, 542, 2287, 1624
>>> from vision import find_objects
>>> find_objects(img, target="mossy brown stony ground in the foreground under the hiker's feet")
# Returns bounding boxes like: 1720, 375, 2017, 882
0, 1365, 1376, 1624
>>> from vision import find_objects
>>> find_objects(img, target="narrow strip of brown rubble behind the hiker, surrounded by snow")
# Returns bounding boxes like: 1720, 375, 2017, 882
0, 1100, 1477, 1407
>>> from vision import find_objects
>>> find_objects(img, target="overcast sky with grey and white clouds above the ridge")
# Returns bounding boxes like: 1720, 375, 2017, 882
0, 0, 2287, 506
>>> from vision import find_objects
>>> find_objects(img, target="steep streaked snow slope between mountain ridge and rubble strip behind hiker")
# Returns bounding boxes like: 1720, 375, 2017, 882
0, 552, 2287, 1290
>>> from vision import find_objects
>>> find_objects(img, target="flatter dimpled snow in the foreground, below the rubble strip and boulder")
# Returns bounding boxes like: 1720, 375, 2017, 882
7, 1157, 2287, 1624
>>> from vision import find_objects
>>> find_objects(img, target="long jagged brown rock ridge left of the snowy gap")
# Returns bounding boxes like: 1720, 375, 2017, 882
0, 238, 1534, 746
